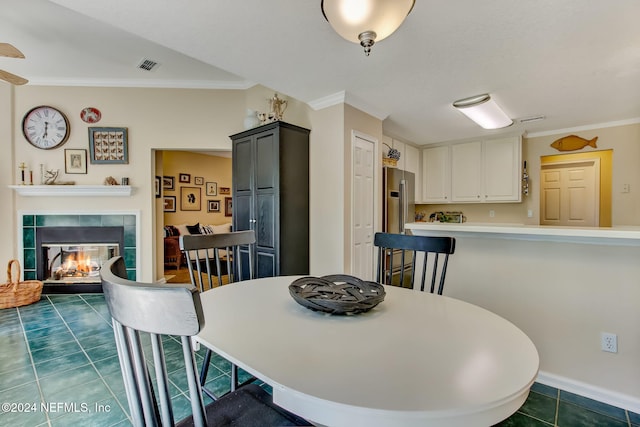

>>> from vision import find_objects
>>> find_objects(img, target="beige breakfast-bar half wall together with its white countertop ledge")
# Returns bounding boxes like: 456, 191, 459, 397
406, 222, 640, 413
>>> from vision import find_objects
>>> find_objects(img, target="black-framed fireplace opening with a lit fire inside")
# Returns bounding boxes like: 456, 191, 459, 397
36, 227, 124, 293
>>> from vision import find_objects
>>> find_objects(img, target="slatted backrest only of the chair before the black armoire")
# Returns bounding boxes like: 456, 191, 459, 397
180, 230, 256, 292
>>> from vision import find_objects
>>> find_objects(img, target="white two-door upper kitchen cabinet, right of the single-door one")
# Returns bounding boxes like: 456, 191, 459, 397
451, 137, 522, 203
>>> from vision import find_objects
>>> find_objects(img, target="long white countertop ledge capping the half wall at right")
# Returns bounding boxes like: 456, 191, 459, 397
405, 222, 640, 246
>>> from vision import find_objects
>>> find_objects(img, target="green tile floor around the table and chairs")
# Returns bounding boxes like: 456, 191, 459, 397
0, 294, 640, 427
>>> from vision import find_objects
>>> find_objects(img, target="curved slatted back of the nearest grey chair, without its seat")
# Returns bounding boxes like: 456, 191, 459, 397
100, 257, 206, 427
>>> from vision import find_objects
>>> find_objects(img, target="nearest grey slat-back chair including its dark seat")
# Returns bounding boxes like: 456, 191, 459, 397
101, 257, 309, 427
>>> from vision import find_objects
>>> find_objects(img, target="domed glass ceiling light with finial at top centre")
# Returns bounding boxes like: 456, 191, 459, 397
320, 0, 415, 56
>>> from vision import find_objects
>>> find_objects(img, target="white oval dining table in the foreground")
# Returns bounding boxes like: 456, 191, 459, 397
196, 276, 539, 427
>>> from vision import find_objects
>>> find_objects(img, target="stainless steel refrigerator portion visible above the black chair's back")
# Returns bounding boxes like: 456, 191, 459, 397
382, 168, 416, 234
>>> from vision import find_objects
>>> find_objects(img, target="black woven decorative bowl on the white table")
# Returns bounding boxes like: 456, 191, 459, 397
289, 274, 385, 314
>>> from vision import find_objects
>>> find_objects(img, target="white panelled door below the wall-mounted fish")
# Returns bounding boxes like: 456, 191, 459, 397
540, 159, 600, 227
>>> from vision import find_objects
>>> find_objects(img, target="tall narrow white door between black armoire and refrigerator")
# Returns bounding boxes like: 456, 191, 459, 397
351, 132, 375, 280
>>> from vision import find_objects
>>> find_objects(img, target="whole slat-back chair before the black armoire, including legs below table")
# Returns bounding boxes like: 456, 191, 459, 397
180, 230, 256, 399
